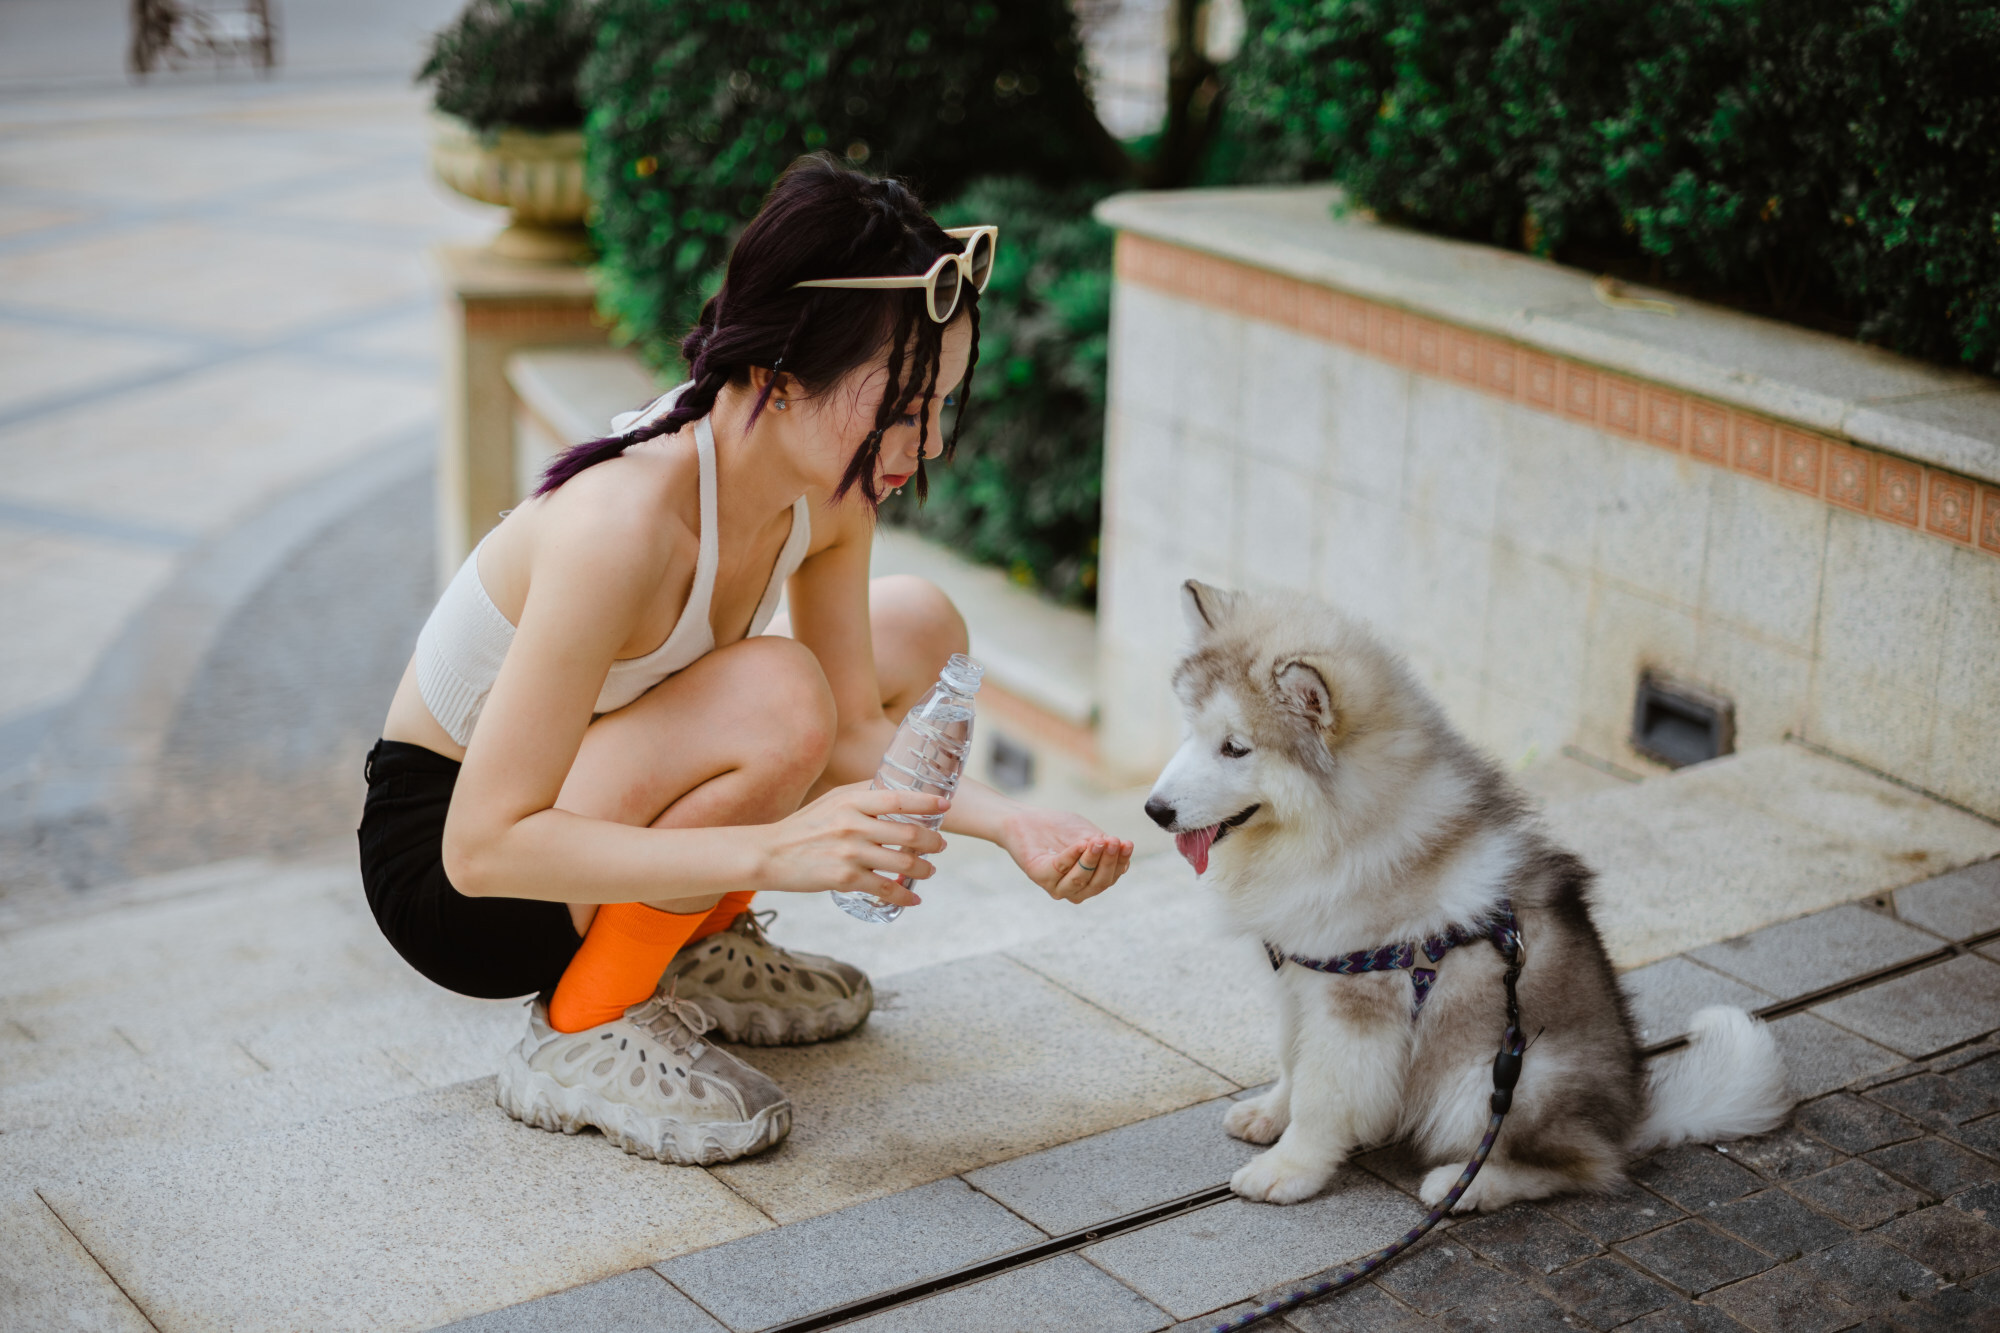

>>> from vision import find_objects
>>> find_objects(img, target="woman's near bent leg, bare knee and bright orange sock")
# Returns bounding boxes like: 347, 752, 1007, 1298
550, 638, 834, 1031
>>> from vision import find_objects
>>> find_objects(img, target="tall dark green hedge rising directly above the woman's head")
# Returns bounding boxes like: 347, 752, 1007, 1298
582, 0, 1118, 366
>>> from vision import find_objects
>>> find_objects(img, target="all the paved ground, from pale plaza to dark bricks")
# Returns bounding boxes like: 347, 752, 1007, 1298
0, 28, 2000, 1333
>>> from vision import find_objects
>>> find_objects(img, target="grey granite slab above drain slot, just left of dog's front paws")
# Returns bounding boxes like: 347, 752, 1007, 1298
966, 1099, 1262, 1235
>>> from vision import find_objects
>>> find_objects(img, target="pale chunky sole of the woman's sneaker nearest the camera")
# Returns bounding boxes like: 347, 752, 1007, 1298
494, 1051, 792, 1167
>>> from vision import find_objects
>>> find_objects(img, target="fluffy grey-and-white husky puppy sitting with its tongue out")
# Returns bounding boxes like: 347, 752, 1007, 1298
1146, 580, 1790, 1211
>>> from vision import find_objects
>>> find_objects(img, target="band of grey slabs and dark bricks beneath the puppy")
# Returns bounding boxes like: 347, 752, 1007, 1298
452, 861, 2000, 1333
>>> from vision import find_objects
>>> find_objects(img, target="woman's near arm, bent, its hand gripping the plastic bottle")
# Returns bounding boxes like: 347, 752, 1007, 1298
444, 478, 942, 903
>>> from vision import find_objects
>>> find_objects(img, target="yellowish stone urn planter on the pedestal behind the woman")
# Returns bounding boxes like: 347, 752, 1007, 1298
430, 112, 592, 264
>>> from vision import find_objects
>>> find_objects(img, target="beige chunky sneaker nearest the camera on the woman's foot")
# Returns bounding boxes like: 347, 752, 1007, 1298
496, 993, 792, 1167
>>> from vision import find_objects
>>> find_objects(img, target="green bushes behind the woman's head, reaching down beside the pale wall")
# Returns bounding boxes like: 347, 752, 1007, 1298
582, 0, 1124, 600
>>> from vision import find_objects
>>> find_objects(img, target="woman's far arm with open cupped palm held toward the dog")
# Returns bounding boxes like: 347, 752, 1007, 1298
788, 504, 1132, 903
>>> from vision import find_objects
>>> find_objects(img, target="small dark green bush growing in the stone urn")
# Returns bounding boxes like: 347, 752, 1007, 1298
416, 0, 598, 130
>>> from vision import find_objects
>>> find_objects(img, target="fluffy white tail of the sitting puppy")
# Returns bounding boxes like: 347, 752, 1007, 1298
1632, 1005, 1792, 1153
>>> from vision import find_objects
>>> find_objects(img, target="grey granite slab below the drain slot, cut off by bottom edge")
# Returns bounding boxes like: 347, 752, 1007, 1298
842, 1255, 1174, 1333
